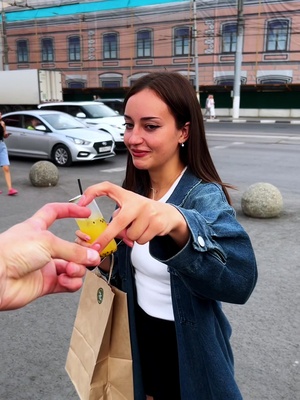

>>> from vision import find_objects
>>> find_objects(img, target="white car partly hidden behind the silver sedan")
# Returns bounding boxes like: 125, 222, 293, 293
38, 101, 126, 150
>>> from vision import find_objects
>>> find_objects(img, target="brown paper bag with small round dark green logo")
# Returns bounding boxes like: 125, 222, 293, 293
66, 271, 134, 400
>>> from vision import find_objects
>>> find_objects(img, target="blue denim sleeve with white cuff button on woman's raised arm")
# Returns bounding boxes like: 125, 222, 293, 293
149, 184, 257, 304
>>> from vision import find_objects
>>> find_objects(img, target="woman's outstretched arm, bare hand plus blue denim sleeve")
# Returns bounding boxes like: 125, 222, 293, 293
80, 182, 257, 304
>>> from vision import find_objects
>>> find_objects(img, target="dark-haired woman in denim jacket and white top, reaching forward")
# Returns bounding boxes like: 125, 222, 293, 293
77, 72, 257, 400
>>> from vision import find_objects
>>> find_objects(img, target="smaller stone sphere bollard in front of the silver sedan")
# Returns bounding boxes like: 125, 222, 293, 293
29, 161, 59, 187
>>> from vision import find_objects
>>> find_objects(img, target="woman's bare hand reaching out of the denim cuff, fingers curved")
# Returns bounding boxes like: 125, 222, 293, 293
79, 182, 189, 253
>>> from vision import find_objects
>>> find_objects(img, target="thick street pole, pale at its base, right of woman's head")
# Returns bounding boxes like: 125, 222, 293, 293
232, 0, 244, 118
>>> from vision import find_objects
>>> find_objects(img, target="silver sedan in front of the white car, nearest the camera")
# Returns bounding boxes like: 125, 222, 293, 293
2, 110, 115, 167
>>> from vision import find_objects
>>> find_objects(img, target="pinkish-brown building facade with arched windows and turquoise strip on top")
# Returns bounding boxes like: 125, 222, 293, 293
2, 0, 300, 107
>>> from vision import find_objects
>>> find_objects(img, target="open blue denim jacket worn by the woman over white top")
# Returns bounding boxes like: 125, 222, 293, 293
112, 170, 257, 400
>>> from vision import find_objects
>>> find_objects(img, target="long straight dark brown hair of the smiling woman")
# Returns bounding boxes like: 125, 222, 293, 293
123, 71, 232, 203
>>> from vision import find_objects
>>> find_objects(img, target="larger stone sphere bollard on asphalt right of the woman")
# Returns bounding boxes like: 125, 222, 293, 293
241, 182, 283, 218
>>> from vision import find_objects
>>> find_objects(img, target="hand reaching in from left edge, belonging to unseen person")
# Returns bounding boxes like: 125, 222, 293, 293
0, 203, 100, 310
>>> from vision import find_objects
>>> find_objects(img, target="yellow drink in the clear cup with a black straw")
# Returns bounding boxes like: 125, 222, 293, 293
76, 218, 117, 257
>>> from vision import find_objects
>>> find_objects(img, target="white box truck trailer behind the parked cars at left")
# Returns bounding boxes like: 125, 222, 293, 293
0, 69, 63, 113
